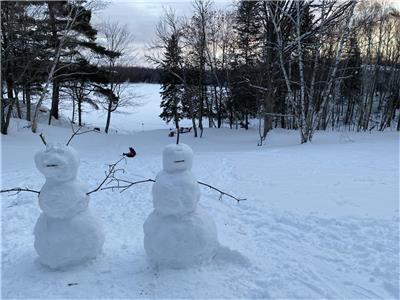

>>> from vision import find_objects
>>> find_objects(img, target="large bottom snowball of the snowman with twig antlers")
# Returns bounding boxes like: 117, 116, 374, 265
34, 210, 104, 269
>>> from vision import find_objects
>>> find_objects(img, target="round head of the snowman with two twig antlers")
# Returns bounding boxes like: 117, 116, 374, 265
35, 144, 79, 182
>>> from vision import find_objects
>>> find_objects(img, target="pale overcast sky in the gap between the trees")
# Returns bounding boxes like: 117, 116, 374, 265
93, 0, 232, 65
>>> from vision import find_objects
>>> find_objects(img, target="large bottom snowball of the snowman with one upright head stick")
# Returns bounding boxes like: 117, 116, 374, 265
143, 207, 219, 269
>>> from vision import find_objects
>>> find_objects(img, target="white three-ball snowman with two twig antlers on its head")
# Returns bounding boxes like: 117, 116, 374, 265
34, 144, 104, 269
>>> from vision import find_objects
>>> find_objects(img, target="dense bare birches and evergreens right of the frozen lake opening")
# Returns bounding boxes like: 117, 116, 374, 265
154, 0, 400, 144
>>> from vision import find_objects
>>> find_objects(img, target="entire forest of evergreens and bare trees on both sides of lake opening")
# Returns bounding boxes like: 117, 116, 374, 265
1, 0, 400, 145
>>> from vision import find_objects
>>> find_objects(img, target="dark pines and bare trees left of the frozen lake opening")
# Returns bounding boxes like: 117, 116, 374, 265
1, 0, 138, 134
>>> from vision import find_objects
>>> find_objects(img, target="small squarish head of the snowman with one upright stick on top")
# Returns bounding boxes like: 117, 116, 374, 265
163, 144, 193, 173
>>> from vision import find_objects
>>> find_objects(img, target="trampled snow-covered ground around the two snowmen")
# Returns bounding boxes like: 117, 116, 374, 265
1, 86, 399, 299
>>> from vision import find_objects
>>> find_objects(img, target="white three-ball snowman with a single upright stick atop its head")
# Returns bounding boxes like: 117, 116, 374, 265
143, 144, 219, 268
